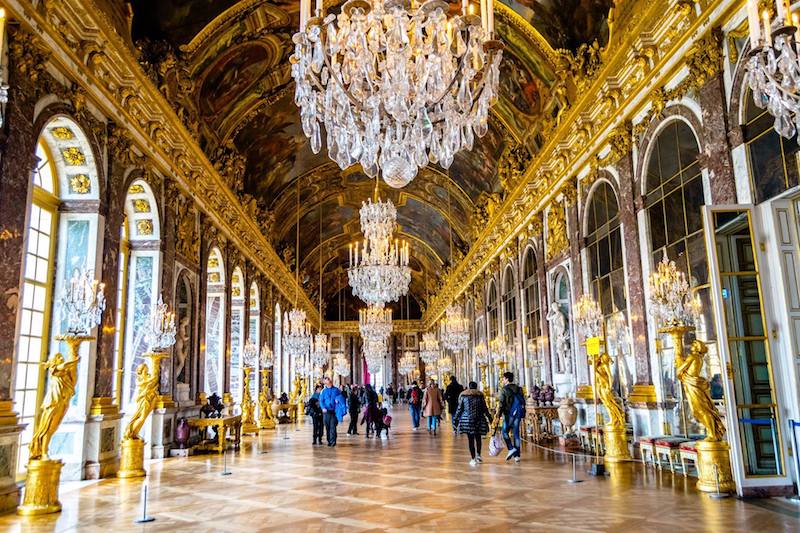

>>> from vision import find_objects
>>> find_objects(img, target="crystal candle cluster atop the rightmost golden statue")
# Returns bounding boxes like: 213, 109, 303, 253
648, 254, 701, 327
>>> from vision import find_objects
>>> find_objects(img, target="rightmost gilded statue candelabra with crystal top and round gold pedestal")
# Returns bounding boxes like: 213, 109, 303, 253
648, 255, 736, 492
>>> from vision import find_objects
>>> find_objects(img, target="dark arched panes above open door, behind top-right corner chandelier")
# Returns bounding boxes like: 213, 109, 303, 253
743, 90, 800, 203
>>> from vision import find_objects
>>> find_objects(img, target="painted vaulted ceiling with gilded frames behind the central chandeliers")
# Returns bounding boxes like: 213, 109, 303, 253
130, 0, 614, 318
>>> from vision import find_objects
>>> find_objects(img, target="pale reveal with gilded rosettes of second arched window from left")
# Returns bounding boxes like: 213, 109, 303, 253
122, 180, 161, 411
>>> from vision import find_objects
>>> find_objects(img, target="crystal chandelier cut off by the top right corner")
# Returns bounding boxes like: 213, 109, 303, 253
746, 0, 800, 142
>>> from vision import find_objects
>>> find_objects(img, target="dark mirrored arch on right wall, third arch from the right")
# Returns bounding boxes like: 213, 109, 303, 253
586, 181, 627, 330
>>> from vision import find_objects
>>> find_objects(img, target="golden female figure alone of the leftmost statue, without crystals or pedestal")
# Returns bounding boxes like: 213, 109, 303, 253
30, 353, 80, 459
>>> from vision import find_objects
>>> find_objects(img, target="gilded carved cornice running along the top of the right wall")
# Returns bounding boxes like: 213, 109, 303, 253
424, 0, 741, 325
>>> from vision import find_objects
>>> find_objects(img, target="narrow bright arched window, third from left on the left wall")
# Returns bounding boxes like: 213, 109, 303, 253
203, 248, 225, 396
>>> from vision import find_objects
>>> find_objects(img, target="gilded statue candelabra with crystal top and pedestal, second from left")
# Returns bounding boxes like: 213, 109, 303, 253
117, 296, 177, 478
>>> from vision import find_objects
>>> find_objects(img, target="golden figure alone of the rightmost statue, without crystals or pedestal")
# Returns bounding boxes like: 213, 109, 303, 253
675, 340, 725, 442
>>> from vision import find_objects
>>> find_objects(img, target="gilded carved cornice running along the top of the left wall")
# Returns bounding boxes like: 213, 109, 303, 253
5, 0, 319, 323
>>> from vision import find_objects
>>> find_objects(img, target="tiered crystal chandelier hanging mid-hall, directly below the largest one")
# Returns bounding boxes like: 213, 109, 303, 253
347, 195, 411, 307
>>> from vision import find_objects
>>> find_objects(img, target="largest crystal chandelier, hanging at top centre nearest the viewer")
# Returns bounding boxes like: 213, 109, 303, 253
291, 0, 503, 187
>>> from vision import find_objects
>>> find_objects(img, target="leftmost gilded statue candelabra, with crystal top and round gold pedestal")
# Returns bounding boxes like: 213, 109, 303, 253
17, 270, 105, 516
